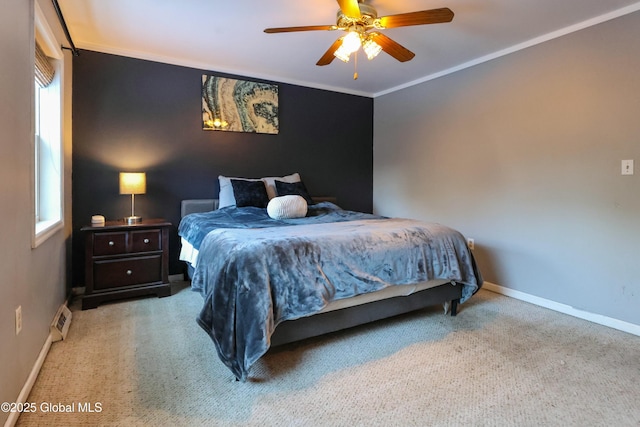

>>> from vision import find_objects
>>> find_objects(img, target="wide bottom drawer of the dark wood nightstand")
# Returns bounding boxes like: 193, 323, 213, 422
93, 254, 162, 290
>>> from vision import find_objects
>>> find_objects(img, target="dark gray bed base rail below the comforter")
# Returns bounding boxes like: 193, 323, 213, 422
271, 283, 462, 347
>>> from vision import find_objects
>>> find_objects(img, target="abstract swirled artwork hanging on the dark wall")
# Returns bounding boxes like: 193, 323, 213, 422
202, 74, 279, 134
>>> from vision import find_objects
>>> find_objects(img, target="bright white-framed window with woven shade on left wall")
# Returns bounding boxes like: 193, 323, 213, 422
32, 7, 64, 247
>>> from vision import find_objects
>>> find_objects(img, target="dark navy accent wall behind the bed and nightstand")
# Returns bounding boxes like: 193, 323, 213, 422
72, 51, 373, 285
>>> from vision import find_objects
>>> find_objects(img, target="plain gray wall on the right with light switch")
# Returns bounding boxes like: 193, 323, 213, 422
373, 13, 640, 325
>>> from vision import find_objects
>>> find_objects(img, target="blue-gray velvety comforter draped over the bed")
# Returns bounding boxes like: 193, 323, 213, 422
179, 202, 482, 380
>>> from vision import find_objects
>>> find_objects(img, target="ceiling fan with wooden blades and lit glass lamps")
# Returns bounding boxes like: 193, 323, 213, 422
264, 0, 453, 79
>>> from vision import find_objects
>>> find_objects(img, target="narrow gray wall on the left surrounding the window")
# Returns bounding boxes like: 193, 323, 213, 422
0, 0, 71, 424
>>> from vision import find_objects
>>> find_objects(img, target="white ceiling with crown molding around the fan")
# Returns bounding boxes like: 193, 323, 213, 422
59, 0, 640, 97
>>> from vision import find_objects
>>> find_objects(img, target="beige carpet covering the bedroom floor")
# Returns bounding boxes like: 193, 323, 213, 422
18, 283, 640, 426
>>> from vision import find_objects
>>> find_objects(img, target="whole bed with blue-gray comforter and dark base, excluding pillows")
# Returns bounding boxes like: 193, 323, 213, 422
178, 174, 482, 381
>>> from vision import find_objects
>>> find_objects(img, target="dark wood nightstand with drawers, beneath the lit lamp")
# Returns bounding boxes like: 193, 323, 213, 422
81, 219, 171, 310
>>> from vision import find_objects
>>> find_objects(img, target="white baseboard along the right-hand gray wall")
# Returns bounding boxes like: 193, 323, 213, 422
482, 282, 640, 336
